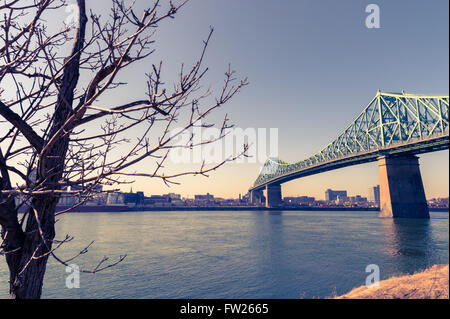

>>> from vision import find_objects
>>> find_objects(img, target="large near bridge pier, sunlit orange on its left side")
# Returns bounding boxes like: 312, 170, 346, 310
378, 155, 430, 218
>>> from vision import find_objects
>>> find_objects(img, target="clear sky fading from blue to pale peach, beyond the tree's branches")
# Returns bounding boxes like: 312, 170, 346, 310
3, 0, 449, 199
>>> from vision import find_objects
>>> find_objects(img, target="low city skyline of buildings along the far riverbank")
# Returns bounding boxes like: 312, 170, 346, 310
48, 185, 449, 212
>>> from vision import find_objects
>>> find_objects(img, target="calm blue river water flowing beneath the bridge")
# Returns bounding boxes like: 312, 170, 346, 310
0, 211, 449, 298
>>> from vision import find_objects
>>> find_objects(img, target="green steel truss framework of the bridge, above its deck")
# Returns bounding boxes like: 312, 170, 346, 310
253, 91, 449, 188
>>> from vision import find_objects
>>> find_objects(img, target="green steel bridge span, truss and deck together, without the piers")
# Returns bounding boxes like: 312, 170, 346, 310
249, 91, 449, 191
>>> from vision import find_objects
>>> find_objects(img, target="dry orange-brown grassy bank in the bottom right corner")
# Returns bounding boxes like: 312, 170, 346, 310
336, 265, 449, 299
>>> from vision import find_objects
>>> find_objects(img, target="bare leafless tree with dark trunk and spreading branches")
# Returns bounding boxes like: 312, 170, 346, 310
0, 0, 247, 298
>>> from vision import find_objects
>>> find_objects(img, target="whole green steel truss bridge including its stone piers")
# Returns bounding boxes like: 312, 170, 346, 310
249, 91, 449, 218
